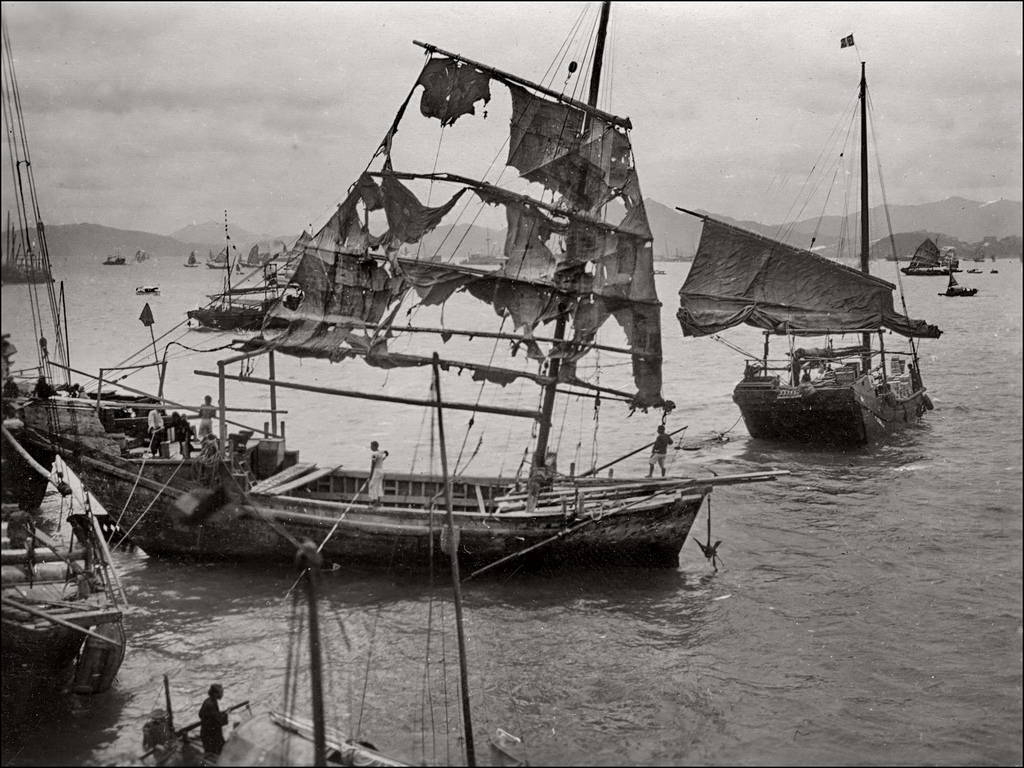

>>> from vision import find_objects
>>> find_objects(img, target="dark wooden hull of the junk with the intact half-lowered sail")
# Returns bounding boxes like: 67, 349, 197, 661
732, 377, 929, 446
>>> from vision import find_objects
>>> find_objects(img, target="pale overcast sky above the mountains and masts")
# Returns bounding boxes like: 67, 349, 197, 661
3, 2, 1024, 234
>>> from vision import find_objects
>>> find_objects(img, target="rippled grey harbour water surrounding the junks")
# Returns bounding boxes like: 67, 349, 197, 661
2, 256, 1022, 765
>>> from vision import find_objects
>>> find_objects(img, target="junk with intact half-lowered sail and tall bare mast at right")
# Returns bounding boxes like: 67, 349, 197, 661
678, 65, 941, 445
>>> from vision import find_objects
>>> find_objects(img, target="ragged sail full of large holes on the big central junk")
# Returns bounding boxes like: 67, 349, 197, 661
249, 45, 666, 409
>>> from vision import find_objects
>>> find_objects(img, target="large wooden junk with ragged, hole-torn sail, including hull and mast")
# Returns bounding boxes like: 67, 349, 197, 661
12, 4, 785, 575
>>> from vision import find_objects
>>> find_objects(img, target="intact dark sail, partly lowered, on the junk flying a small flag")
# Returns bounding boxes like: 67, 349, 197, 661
678, 218, 941, 339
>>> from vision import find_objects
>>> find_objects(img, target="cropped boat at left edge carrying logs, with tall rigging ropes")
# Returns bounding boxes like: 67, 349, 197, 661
0, 16, 127, 748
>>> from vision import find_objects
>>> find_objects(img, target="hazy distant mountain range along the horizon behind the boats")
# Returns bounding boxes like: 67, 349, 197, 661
4, 198, 1024, 264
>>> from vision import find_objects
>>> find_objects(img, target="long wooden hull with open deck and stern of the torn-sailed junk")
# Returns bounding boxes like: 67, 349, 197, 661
18, 406, 712, 568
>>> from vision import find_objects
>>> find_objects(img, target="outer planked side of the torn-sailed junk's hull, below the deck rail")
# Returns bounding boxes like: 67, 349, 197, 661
66, 453, 711, 568
